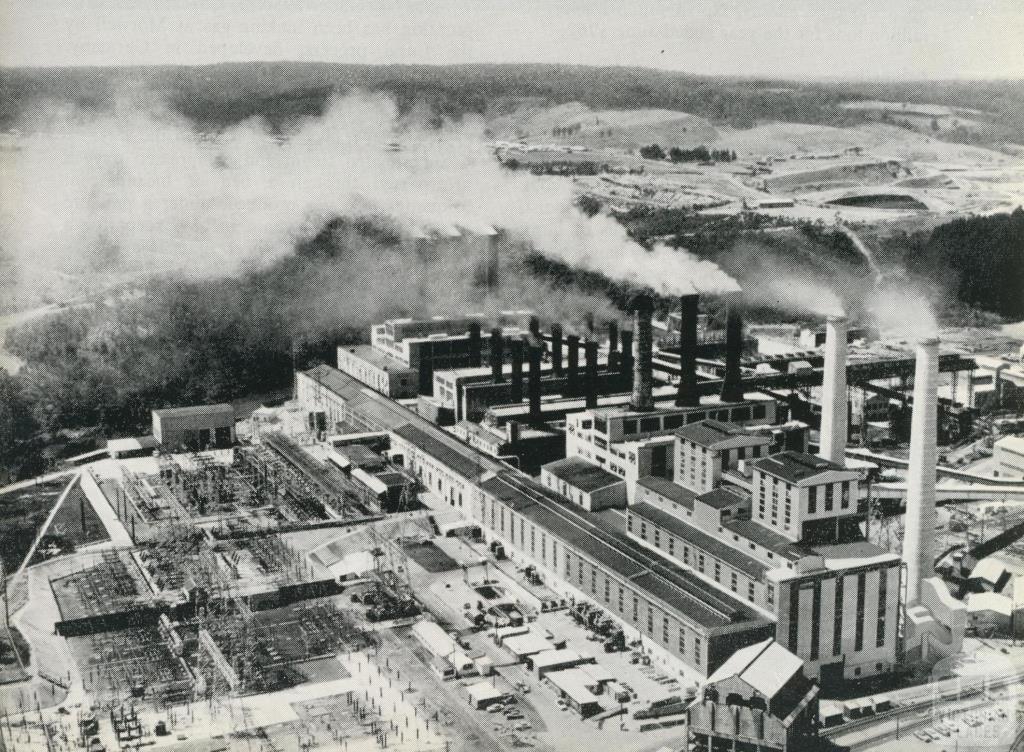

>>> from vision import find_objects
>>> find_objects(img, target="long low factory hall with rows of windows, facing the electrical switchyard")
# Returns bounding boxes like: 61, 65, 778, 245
296, 366, 775, 676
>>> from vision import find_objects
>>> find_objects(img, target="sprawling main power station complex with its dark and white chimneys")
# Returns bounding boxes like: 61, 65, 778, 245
297, 296, 966, 684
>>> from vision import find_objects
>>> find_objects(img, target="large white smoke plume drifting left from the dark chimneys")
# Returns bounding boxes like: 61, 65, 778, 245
0, 94, 737, 303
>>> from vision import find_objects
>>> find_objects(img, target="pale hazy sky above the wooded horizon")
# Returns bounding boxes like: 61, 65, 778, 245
0, 0, 1024, 78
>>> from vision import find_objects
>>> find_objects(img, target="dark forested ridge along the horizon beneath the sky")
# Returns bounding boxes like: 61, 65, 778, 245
0, 62, 1024, 140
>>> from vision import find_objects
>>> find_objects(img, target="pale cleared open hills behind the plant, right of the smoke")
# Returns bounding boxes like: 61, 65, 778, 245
488, 102, 1024, 224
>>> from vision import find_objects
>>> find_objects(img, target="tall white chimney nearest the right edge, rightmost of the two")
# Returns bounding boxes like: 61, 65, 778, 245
903, 337, 939, 605
